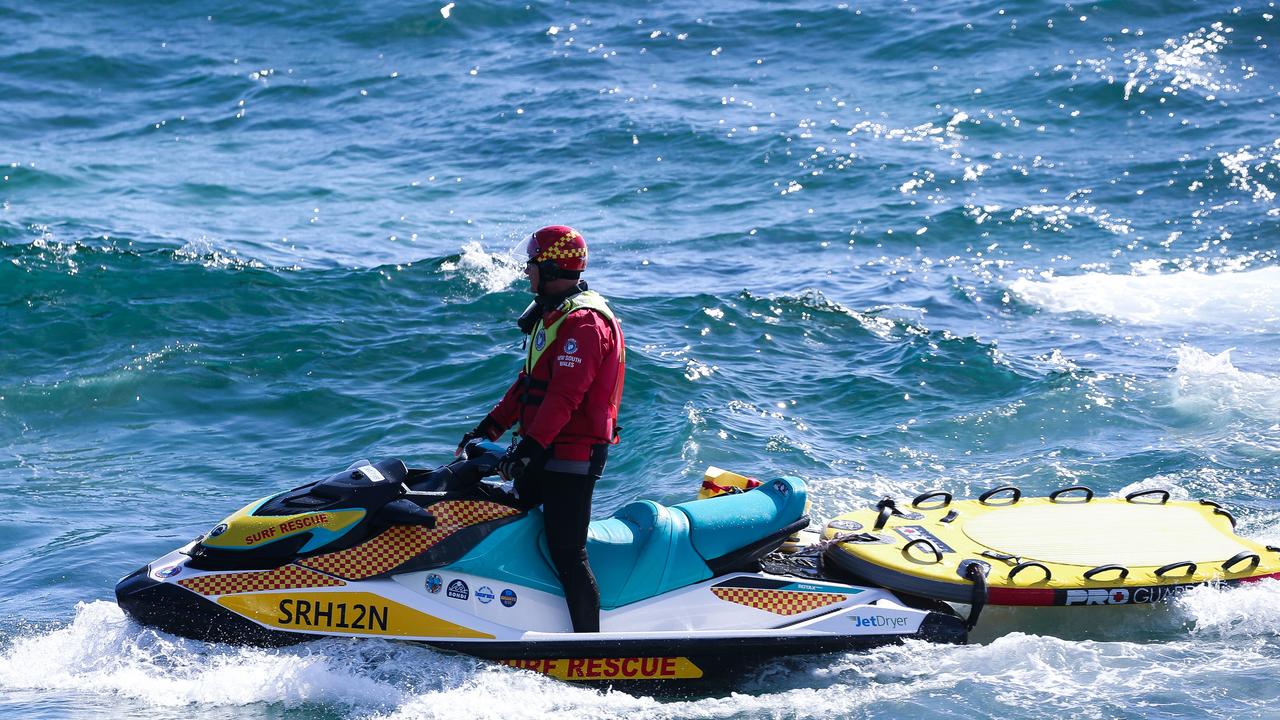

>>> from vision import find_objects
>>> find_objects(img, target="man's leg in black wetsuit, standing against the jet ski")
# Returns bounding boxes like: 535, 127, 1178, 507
540, 473, 600, 633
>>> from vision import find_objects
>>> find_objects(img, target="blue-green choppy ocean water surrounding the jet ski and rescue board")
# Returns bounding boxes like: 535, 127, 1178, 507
0, 0, 1280, 720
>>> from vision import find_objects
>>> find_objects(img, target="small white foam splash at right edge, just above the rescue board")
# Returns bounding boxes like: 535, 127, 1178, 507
1172, 346, 1280, 423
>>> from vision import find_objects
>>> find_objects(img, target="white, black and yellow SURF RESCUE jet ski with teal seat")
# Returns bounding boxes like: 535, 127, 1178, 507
115, 442, 966, 685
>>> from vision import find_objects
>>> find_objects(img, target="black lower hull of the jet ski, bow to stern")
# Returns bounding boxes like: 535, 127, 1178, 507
115, 568, 966, 688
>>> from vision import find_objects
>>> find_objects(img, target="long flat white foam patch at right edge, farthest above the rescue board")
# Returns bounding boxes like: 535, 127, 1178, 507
1009, 266, 1280, 324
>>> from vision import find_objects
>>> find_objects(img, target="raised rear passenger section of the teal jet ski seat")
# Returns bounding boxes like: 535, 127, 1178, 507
673, 477, 808, 561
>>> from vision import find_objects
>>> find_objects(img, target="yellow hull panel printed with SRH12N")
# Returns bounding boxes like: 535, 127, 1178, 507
218, 592, 493, 639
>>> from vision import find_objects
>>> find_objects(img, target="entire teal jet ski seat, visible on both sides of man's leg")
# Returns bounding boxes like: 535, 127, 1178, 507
448, 478, 805, 610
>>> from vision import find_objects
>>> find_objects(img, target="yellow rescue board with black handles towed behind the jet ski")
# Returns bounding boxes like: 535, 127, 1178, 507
823, 487, 1280, 606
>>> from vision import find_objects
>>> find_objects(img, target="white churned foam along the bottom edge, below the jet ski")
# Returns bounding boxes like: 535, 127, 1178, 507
0, 594, 1280, 720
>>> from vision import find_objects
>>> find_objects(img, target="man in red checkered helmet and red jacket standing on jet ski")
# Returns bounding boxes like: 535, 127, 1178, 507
458, 225, 626, 633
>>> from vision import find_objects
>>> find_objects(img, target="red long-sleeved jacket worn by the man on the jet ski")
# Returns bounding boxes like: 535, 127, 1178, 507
489, 302, 625, 460
